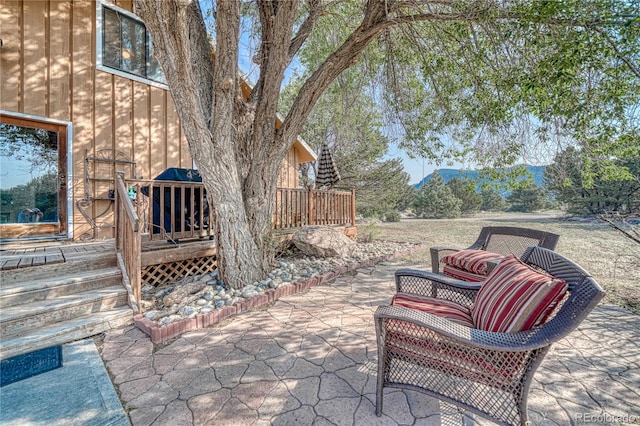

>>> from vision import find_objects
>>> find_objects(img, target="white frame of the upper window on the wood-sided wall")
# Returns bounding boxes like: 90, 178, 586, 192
96, 0, 169, 90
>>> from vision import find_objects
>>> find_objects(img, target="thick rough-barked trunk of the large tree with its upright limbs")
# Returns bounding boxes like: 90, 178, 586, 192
135, 0, 297, 288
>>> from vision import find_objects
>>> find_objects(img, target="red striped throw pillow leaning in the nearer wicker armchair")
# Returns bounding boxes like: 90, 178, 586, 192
471, 255, 568, 333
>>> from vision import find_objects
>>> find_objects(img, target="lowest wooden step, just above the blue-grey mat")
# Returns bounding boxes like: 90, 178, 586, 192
0, 306, 133, 360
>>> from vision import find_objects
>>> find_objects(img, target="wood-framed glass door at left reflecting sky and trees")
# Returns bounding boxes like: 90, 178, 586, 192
0, 114, 68, 240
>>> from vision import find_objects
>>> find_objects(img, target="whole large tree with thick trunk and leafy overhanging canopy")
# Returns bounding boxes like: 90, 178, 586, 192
134, 0, 640, 287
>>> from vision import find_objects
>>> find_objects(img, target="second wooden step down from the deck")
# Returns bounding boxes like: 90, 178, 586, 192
0, 266, 122, 309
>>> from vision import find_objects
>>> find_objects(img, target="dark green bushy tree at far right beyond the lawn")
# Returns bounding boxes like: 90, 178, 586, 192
544, 147, 640, 215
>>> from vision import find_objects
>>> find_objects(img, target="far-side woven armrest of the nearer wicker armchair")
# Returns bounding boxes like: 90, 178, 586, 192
395, 269, 482, 307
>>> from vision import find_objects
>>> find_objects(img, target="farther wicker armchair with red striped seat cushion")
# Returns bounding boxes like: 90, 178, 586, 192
430, 226, 560, 281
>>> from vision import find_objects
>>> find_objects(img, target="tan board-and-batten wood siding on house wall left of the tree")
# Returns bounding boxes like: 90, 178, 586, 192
0, 0, 193, 238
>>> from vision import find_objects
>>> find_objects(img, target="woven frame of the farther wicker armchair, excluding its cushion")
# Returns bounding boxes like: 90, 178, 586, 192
430, 226, 560, 281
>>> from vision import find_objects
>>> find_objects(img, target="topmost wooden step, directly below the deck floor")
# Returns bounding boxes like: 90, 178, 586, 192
0, 249, 118, 287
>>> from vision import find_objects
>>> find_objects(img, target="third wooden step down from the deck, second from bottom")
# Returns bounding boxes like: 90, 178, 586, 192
0, 285, 128, 338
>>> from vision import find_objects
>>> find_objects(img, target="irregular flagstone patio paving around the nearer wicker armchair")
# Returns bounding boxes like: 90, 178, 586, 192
102, 262, 640, 426
